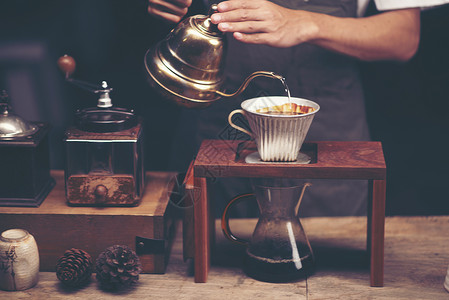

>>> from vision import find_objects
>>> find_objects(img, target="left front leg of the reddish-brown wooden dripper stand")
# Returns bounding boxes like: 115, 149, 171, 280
194, 177, 210, 283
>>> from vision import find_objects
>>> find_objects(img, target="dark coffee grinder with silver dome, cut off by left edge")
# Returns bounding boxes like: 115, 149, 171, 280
0, 91, 55, 207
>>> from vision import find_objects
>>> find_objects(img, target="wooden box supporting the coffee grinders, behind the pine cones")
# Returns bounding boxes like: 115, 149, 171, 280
0, 171, 176, 273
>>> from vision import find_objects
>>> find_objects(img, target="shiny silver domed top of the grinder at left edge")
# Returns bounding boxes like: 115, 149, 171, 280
0, 91, 38, 139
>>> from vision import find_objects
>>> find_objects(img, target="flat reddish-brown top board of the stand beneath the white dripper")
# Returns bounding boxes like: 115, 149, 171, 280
194, 140, 386, 179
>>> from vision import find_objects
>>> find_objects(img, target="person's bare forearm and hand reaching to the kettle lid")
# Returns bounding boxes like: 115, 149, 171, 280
211, 0, 420, 61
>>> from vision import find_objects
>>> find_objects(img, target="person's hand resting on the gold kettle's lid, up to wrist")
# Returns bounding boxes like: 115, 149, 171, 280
211, 0, 318, 47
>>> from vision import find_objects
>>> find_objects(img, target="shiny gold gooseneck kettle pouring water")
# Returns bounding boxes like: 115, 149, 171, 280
144, 4, 284, 108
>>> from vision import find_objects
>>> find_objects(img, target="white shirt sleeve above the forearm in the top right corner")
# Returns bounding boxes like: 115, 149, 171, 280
357, 0, 449, 17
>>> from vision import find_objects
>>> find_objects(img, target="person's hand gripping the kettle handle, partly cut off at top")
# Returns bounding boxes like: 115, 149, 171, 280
148, 0, 192, 23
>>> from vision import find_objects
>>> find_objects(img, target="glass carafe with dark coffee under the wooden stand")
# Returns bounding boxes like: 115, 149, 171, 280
222, 183, 314, 282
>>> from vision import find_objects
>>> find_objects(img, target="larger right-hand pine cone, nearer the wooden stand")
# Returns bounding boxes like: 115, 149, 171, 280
96, 245, 142, 289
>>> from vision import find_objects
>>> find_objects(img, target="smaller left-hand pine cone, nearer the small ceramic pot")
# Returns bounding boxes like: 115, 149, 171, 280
56, 248, 93, 287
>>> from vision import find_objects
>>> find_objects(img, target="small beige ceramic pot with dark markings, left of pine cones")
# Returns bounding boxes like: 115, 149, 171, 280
0, 229, 39, 291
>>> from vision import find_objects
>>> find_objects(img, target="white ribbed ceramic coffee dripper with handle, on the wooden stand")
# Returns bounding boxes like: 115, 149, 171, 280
228, 96, 320, 162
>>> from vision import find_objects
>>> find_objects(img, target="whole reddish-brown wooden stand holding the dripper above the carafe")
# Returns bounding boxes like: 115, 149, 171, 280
185, 140, 386, 286
